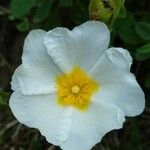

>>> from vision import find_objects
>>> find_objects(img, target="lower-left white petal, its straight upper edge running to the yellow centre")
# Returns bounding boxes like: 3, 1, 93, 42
9, 92, 72, 145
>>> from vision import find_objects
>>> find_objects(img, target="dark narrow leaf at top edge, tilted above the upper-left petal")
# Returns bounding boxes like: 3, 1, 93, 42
33, 0, 54, 23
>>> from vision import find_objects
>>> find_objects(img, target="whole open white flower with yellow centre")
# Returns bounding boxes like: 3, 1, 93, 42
10, 21, 145, 150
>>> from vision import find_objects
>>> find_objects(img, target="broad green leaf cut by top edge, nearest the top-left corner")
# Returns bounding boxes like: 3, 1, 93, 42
10, 0, 35, 18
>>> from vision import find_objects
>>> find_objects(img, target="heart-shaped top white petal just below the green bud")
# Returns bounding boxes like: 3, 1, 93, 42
44, 21, 110, 72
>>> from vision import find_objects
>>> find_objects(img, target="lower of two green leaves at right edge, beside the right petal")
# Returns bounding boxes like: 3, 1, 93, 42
135, 44, 150, 60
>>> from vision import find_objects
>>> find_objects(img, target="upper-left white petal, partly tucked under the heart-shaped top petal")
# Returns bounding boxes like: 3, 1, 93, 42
11, 30, 61, 95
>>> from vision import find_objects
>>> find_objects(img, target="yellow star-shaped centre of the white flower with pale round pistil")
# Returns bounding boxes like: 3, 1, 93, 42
56, 67, 99, 110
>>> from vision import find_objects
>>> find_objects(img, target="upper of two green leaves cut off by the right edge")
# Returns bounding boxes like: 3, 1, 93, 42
136, 22, 150, 40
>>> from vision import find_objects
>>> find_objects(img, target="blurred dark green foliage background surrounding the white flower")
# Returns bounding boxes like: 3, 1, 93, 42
0, 0, 150, 150
